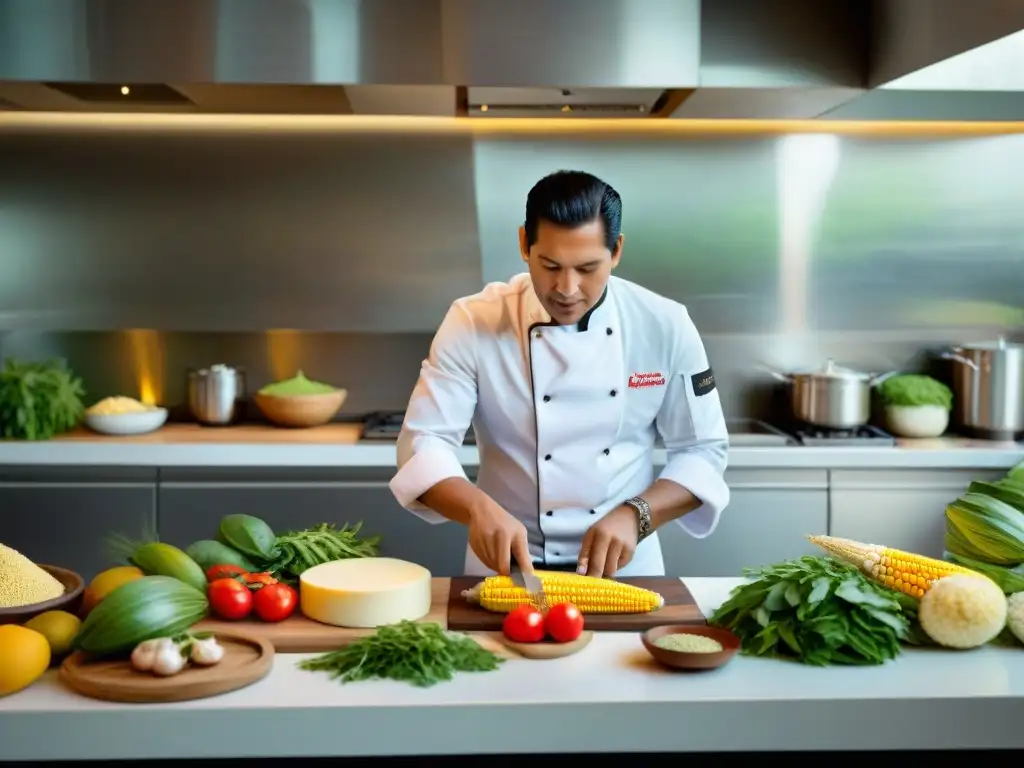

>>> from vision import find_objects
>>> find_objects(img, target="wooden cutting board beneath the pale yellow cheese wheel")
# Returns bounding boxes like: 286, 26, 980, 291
194, 579, 452, 653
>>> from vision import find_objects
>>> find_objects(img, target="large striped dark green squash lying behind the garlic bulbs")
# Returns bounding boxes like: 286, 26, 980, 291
73, 575, 209, 655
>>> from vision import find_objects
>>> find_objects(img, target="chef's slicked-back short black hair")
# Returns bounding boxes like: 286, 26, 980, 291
524, 171, 623, 251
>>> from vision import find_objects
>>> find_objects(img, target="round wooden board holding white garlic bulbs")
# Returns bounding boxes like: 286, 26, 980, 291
60, 632, 273, 703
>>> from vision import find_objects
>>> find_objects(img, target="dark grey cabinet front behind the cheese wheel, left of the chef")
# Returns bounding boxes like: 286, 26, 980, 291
158, 467, 472, 577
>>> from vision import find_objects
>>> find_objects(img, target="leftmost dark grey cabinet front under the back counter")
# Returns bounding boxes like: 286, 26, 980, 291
0, 467, 157, 581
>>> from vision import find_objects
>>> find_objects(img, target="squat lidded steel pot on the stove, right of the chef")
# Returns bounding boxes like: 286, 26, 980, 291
770, 360, 896, 429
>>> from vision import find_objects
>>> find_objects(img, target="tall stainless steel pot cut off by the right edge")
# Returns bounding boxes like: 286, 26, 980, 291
941, 337, 1024, 440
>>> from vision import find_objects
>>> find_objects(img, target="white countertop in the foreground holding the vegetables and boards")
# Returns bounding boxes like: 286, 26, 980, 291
0, 579, 1024, 760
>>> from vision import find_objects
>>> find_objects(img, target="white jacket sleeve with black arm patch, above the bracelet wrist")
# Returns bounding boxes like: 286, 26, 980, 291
656, 309, 729, 539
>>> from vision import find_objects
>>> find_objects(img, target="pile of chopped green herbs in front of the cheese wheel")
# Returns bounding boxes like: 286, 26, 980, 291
299, 622, 505, 688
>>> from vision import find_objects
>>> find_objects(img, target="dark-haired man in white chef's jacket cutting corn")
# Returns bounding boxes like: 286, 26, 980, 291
390, 171, 729, 577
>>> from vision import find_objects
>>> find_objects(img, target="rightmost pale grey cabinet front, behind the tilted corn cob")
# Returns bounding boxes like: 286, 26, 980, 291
828, 469, 1006, 558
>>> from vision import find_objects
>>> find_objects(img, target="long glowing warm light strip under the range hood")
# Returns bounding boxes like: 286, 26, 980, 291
0, 112, 1024, 137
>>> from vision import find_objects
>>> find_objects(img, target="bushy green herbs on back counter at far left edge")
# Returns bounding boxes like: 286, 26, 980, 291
0, 358, 85, 440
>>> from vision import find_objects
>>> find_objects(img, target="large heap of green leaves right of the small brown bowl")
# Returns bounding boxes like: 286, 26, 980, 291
709, 557, 920, 666
